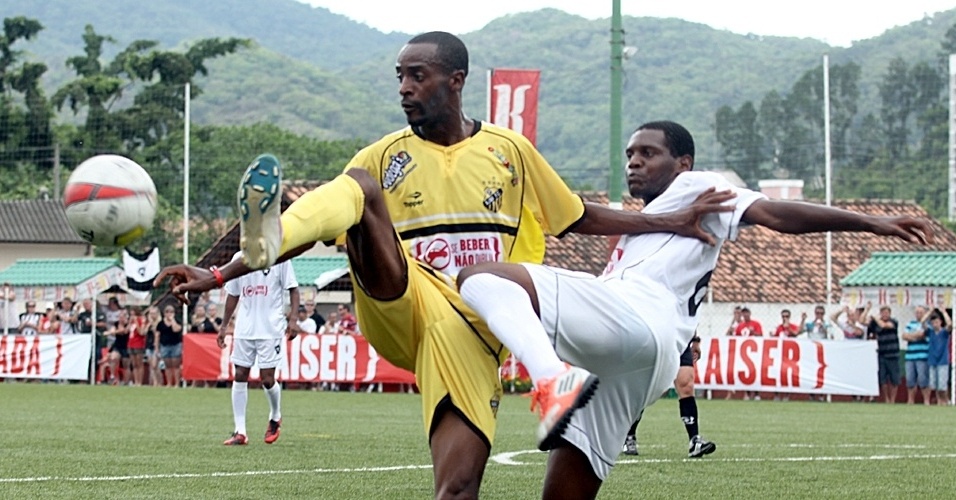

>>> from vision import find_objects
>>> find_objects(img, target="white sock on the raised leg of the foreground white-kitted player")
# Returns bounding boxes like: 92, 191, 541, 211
461, 273, 564, 384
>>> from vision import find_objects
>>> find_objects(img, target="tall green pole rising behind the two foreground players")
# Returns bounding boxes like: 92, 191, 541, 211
607, 0, 624, 209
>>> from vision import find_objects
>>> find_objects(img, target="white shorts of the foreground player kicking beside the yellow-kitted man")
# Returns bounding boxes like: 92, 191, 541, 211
524, 264, 680, 481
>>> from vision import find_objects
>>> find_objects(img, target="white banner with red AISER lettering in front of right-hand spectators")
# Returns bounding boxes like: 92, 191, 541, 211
694, 337, 880, 396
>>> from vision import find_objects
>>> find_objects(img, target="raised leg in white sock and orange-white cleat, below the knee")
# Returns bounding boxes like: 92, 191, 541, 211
458, 263, 598, 450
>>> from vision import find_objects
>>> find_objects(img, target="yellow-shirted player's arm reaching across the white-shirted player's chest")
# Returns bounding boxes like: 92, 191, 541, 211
574, 188, 737, 245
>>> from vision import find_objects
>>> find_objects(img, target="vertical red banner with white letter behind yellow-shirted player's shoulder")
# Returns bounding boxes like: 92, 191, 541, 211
489, 69, 541, 144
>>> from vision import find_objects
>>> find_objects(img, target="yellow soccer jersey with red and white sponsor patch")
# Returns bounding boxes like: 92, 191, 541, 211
346, 122, 584, 276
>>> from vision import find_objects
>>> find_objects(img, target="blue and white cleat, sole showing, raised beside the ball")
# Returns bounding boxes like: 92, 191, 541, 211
238, 154, 282, 269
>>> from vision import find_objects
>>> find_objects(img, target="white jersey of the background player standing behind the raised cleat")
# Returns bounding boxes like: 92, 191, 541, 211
225, 253, 299, 339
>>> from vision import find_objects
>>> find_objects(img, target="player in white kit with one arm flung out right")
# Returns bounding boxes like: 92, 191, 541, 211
458, 121, 932, 499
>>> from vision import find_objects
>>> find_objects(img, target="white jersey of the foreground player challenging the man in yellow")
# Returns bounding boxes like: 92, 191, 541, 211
601, 171, 766, 352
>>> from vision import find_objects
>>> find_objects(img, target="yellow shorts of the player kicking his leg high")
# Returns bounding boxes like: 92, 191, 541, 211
352, 252, 508, 446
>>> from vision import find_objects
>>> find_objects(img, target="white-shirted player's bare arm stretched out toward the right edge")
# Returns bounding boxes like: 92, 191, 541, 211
743, 200, 933, 245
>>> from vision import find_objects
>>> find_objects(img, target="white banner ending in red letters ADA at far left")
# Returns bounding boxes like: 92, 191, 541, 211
0, 334, 92, 380
